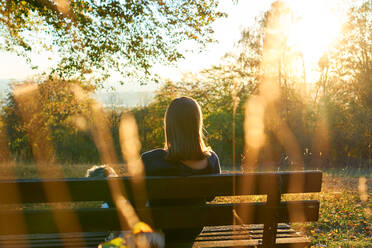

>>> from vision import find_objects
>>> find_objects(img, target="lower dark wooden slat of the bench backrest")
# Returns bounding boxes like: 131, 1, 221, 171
0, 200, 319, 235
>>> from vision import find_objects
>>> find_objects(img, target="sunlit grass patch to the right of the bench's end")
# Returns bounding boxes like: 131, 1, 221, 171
303, 173, 372, 247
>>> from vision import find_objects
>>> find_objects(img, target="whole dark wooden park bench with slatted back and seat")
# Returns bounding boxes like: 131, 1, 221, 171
0, 171, 322, 248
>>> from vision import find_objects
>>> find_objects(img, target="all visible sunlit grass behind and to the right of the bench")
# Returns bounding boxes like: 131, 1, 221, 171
0, 165, 372, 247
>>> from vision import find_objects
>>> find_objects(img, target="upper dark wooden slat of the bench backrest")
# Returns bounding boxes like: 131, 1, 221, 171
0, 171, 322, 204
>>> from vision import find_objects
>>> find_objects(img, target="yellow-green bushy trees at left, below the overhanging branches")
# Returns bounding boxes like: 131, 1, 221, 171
3, 80, 99, 163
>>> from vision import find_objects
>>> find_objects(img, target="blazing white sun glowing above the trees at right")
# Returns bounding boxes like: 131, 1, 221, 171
288, 0, 345, 83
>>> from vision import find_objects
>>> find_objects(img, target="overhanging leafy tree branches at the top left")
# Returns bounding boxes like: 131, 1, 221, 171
0, 0, 224, 82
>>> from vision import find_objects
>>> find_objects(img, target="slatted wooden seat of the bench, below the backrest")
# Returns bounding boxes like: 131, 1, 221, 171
0, 224, 310, 248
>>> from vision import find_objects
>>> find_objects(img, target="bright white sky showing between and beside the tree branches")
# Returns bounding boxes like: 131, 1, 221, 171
0, 0, 354, 91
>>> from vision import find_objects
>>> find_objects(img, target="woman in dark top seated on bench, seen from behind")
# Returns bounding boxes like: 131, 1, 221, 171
142, 97, 221, 245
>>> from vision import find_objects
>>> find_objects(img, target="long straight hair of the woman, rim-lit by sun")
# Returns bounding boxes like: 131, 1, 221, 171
164, 97, 210, 161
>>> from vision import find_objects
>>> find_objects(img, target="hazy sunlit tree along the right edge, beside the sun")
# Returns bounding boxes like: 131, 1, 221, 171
320, 1, 372, 165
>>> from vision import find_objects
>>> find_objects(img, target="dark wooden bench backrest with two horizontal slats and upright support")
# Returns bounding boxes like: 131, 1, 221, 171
0, 171, 322, 247
